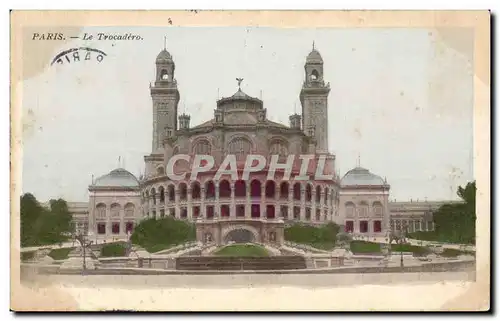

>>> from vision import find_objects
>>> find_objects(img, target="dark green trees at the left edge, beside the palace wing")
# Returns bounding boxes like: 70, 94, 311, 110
21, 193, 72, 246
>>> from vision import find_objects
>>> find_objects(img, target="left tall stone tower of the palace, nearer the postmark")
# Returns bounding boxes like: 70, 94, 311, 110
151, 46, 180, 153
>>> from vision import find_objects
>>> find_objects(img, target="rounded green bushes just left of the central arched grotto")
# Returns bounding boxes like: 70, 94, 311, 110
131, 216, 196, 253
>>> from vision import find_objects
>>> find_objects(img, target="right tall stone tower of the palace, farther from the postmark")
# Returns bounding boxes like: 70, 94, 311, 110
300, 43, 330, 153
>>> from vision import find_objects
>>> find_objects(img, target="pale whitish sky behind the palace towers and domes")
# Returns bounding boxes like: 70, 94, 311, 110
22, 27, 473, 201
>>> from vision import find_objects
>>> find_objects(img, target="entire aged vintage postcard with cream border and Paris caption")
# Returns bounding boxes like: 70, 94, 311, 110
11, 10, 490, 311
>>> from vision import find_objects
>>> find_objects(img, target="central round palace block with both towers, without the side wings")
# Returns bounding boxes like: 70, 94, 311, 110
141, 43, 338, 245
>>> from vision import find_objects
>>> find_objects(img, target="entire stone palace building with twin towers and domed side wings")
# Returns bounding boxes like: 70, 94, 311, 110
76, 48, 439, 244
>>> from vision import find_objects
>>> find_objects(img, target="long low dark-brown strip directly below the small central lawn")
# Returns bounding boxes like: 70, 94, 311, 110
176, 256, 306, 271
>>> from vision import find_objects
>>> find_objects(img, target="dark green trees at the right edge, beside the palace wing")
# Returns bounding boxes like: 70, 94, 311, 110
408, 181, 476, 244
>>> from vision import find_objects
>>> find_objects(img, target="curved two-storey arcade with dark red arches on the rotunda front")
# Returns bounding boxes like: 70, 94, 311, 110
142, 179, 337, 222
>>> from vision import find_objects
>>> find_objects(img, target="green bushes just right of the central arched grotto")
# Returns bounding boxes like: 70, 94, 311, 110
285, 223, 340, 250
